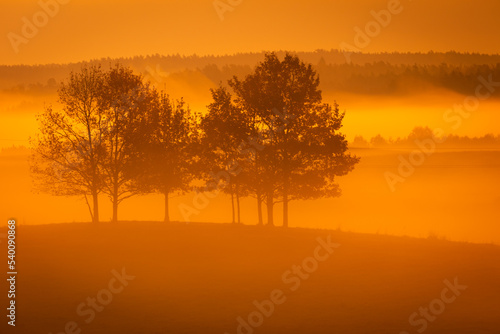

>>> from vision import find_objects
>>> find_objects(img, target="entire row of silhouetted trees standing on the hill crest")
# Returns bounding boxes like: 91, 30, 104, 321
32, 53, 359, 226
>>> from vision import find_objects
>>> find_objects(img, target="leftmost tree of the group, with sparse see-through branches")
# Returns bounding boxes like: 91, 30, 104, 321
31, 66, 107, 223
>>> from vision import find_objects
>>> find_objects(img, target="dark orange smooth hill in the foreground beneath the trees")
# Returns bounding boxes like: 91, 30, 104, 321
0, 222, 500, 334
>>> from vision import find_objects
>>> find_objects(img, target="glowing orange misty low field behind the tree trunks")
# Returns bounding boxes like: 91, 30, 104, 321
0, 148, 500, 244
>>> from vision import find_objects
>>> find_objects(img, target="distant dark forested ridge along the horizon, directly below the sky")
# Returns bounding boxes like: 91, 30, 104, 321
0, 50, 500, 97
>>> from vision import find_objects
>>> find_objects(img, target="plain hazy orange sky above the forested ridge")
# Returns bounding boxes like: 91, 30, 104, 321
0, 0, 500, 64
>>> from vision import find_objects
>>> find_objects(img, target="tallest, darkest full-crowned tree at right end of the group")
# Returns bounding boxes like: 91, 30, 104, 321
230, 53, 359, 227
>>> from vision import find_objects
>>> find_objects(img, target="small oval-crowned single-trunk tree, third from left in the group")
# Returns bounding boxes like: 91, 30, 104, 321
130, 91, 199, 222
